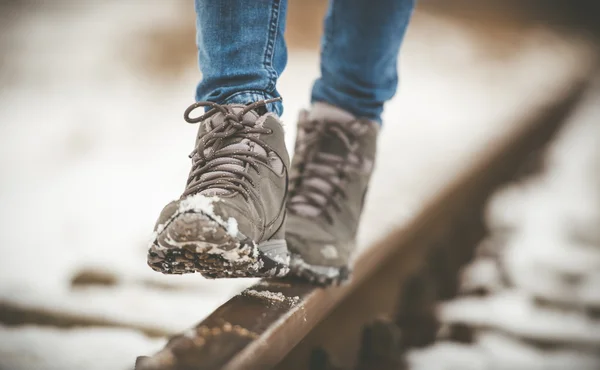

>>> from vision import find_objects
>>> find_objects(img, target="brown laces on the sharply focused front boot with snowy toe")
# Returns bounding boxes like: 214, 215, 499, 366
182, 98, 280, 200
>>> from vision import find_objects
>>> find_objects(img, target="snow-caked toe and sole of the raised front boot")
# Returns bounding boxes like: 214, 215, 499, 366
148, 212, 290, 279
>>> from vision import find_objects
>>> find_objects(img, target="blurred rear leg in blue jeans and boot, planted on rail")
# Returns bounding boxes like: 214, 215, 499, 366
286, 0, 414, 284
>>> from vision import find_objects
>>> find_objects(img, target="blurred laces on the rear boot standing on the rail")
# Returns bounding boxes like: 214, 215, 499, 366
288, 121, 360, 224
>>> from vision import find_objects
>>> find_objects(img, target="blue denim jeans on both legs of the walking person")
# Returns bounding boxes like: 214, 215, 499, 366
195, 0, 415, 122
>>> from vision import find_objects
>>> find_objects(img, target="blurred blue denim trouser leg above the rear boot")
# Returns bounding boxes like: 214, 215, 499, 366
311, 0, 415, 123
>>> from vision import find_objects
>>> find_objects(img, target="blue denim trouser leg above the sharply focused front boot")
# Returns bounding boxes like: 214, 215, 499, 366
195, 0, 287, 116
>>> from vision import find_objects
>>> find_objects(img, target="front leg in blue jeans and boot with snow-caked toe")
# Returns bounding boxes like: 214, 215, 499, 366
148, 0, 289, 278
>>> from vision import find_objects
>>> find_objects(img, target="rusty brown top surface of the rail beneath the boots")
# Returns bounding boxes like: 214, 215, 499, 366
135, 80, 587, 370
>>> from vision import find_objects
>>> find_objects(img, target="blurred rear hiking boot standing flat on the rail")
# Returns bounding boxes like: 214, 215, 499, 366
286, 103, 379, 285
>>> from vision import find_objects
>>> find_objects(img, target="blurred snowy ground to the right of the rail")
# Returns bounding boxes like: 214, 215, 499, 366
408, 79, 600, 370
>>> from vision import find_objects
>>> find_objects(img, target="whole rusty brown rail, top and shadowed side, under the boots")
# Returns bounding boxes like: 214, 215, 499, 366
135, 79, 586, 370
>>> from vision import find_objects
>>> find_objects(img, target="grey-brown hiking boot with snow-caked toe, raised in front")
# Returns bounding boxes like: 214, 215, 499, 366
148, 100, 289, 278
